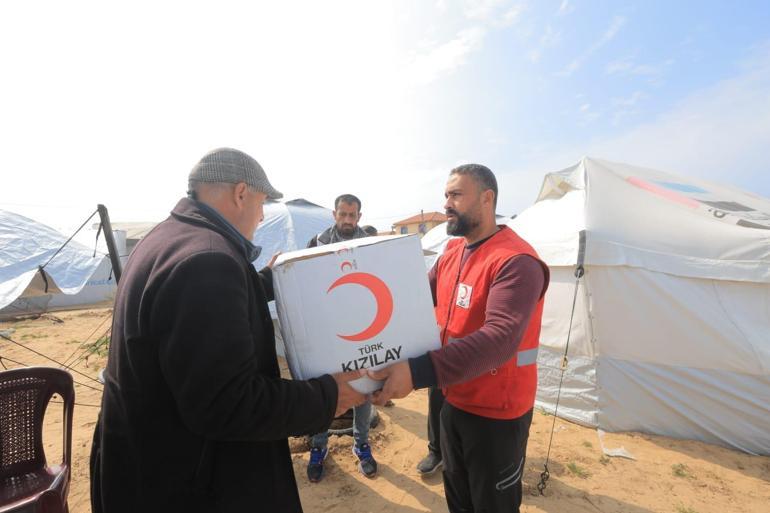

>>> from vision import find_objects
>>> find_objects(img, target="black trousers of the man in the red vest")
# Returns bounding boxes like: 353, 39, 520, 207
441, 402, 532, 513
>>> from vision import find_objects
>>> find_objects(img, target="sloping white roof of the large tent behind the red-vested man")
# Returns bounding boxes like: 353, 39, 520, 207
511, 158, 770, 283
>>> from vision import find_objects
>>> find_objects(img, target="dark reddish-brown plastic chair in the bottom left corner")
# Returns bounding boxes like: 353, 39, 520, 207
0, 367, 75, 513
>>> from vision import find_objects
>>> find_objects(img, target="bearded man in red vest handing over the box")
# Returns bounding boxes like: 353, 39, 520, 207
370, 164, 549, 513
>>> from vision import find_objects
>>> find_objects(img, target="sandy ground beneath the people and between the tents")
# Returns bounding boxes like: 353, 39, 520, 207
0, 309, 770, 513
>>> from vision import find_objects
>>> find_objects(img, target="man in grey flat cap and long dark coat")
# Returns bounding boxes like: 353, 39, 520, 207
91, 148, 365, 513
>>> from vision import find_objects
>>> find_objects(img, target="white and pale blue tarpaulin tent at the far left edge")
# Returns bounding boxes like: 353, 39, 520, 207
0, 210, 114, 315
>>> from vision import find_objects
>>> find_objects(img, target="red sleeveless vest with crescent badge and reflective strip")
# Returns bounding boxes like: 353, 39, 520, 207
436, 227, 545, 419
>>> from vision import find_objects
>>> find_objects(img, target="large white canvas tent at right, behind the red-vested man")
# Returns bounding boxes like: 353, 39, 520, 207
424, 158, 770, 454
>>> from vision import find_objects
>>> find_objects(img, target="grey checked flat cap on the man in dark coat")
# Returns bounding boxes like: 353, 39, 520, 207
188, 148, 283, 199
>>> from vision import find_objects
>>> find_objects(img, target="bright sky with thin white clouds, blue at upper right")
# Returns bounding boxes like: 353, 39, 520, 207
0, 0, 770, 228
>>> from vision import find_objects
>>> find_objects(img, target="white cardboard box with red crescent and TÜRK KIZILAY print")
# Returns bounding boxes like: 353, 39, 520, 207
273, 235, 441, 393
